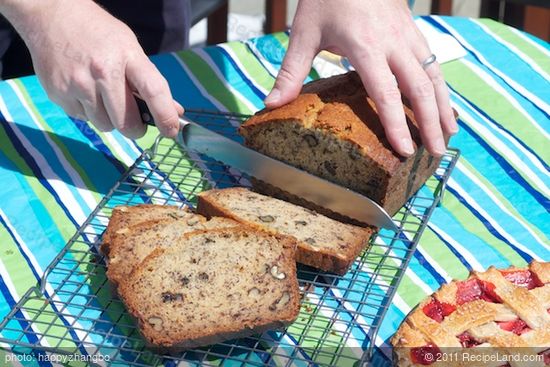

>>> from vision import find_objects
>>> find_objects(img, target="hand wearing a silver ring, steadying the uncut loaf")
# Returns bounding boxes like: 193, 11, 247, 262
265, 0, 458, 156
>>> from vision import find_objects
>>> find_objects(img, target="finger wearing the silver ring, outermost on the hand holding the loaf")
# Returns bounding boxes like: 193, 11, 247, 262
411, 26, 458, 136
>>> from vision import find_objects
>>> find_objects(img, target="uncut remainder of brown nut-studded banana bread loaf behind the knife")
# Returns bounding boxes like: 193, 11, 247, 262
240, 72, 439, 215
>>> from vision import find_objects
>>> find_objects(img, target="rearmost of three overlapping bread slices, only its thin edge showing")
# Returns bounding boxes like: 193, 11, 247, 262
100, 204, 189, 256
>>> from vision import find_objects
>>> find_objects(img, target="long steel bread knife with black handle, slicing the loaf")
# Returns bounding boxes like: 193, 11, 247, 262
136, 97, 398, 232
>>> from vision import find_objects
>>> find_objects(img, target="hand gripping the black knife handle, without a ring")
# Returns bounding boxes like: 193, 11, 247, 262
16, 0, 183, 139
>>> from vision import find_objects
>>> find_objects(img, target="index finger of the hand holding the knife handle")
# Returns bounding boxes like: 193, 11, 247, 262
126, 56, 179, 137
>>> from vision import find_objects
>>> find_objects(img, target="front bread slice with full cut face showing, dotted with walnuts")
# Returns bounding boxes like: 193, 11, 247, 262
119, 226, 299, 350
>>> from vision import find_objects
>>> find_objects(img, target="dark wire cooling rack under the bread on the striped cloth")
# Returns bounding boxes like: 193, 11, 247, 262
0, 111, 459, 367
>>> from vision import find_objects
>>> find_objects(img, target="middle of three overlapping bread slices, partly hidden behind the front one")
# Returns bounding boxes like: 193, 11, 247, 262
107, 211, 238, 287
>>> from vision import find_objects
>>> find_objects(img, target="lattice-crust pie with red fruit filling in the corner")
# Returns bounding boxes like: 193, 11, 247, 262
392, 261, 550, 367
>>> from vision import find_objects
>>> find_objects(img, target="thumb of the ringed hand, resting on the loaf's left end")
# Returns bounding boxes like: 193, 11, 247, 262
264, 35, 317, 108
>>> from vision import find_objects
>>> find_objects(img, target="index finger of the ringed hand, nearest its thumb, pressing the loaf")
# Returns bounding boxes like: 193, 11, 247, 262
348, 51, 414, 157
